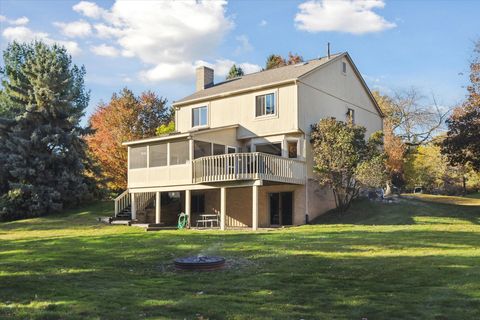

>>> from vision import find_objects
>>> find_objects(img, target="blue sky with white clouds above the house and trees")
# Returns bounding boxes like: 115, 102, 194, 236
0, 0, 480, 124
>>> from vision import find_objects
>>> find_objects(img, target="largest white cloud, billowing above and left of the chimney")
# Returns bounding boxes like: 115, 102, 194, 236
73, 0, 234, 81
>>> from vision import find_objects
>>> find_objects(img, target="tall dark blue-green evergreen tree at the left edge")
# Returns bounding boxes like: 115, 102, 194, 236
0, 42, 92, 219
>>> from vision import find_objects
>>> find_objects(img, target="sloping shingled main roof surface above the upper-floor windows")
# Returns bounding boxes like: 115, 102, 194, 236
173, 53, 346, 106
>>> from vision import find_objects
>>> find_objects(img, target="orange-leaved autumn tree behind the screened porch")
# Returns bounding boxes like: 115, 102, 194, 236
87, 88, 171, 191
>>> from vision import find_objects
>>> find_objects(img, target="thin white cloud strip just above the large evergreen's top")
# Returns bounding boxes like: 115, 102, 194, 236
2, 26, 81, 56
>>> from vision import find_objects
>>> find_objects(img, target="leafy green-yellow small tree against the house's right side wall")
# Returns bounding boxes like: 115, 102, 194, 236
310, 118, 385, 212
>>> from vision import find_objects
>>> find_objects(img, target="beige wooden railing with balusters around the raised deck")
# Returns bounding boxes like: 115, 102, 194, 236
193, 152, 305, 184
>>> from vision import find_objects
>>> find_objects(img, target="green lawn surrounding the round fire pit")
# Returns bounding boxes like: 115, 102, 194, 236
0, 197, 480, 320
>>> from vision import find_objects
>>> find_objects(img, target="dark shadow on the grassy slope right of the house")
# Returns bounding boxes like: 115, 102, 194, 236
312, 199, 480, 225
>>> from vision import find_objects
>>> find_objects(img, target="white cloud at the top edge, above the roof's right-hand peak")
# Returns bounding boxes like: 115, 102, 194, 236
295, 0, 396, 34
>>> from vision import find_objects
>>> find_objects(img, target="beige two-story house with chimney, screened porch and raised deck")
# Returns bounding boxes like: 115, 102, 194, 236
115, 53, 382, 230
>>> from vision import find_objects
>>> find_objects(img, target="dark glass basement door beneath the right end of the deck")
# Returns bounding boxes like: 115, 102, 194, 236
268, 192, 293, 226
